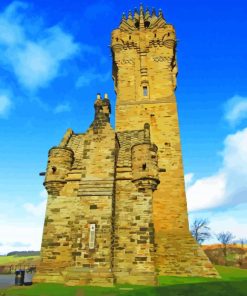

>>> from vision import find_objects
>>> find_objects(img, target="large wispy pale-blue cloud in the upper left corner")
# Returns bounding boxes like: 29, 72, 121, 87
0, 2, 79, 90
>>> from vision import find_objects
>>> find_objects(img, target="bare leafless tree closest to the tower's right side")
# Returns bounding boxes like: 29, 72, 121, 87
190, 218, 211, 245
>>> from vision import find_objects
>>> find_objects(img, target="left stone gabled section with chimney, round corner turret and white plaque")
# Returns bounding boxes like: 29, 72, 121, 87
36, 98, 117, 285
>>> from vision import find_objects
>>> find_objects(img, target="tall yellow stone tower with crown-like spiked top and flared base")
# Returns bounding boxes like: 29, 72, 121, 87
112, 7, 217, 276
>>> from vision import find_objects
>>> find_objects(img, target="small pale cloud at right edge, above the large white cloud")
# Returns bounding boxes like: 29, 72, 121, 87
225, 95, 247, 125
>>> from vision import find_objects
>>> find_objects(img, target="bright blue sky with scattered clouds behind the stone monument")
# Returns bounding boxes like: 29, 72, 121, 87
0, 0, 247, 253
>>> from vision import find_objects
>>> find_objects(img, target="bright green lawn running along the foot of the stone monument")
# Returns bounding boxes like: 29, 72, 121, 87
0, 266, 247, 296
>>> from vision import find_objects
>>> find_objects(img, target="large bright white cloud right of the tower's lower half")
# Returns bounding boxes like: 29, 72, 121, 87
186, 128, 247, 211
